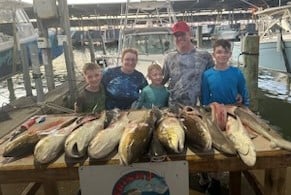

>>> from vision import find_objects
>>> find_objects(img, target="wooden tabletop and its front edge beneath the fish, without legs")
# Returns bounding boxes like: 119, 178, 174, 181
0, 114, 291, 171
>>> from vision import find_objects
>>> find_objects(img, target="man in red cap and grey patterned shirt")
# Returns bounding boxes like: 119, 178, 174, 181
163, 21, 214, 106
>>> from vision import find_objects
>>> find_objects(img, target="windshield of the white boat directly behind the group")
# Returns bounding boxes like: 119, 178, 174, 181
124, 33, 174, 55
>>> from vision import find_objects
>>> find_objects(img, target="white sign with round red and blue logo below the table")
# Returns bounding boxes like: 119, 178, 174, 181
79, 161, 189, 195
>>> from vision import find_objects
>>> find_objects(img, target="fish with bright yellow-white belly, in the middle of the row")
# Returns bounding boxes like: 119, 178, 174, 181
156, 111, 185, 153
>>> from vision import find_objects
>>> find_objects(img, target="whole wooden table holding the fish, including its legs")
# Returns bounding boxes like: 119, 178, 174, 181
0, 114, 291, 195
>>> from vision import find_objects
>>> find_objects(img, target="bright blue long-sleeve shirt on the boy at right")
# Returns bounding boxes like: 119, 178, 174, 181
201, 66, 249, 106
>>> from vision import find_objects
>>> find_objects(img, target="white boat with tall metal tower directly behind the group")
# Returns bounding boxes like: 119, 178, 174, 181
101, 0, 177, 73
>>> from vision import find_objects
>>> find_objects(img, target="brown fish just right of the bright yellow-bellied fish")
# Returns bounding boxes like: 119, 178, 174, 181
180, 106, 212, 151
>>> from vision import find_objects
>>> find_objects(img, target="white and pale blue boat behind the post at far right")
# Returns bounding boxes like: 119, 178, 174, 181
232, 5, 291, 73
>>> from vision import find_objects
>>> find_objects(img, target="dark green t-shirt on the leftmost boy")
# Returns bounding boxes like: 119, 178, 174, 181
76, 85, 105, 112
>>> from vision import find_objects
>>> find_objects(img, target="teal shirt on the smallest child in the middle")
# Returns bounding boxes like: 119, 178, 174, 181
136, 85, 169, 108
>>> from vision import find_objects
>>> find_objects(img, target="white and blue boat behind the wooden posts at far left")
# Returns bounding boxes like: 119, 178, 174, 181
0, 0, 63, 80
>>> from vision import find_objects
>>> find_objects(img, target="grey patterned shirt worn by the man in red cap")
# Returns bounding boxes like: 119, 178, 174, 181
163, 48, 214, 106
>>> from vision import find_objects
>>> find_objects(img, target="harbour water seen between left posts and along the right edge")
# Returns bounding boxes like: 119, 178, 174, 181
0, 45, 291, 141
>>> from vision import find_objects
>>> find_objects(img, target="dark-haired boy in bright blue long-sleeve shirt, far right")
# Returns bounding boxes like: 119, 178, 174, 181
201, 39, 249, 106
